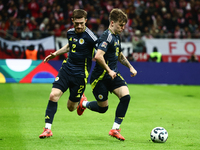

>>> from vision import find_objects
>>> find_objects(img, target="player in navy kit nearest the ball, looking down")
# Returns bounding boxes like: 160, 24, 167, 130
77, 9, 137, 141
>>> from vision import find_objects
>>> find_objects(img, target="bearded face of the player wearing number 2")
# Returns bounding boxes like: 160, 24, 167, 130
72, 18, 87, 33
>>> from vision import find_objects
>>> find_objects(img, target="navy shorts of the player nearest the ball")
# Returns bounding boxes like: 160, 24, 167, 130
93, 73, 127, 101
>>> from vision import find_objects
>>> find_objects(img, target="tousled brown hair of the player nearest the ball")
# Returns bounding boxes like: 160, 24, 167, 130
109, 8, 128, 23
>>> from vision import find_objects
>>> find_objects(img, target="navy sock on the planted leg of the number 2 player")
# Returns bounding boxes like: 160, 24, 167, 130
45, 100, 57, 124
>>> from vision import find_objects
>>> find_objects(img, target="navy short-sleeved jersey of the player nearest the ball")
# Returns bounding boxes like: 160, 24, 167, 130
91, 29, 121, 82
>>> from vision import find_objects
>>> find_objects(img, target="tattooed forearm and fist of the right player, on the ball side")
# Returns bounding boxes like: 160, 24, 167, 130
118, 52, 137, 77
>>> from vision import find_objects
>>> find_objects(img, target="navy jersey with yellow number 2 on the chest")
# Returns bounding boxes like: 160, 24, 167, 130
62, 27, 97, 78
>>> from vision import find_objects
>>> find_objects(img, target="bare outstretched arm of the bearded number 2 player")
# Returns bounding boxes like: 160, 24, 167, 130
44, 44, 69, 63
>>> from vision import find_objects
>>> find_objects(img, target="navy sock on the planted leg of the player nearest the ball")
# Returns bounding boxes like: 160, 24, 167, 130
115, 95, 130, 124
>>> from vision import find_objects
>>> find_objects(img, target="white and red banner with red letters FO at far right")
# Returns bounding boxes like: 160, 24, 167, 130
145, 39, 200, 62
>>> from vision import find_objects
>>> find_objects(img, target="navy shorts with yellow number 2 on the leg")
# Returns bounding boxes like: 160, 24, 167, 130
53, 69, 86, 102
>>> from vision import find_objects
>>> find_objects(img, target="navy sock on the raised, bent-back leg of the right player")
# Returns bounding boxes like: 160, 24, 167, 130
86, 101, 108, 113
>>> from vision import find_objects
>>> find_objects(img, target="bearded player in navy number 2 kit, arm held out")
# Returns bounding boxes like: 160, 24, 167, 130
39, 9, 97, 138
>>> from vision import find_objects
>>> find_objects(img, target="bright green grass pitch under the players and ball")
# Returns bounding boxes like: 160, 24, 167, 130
0, 84, 200, 150
